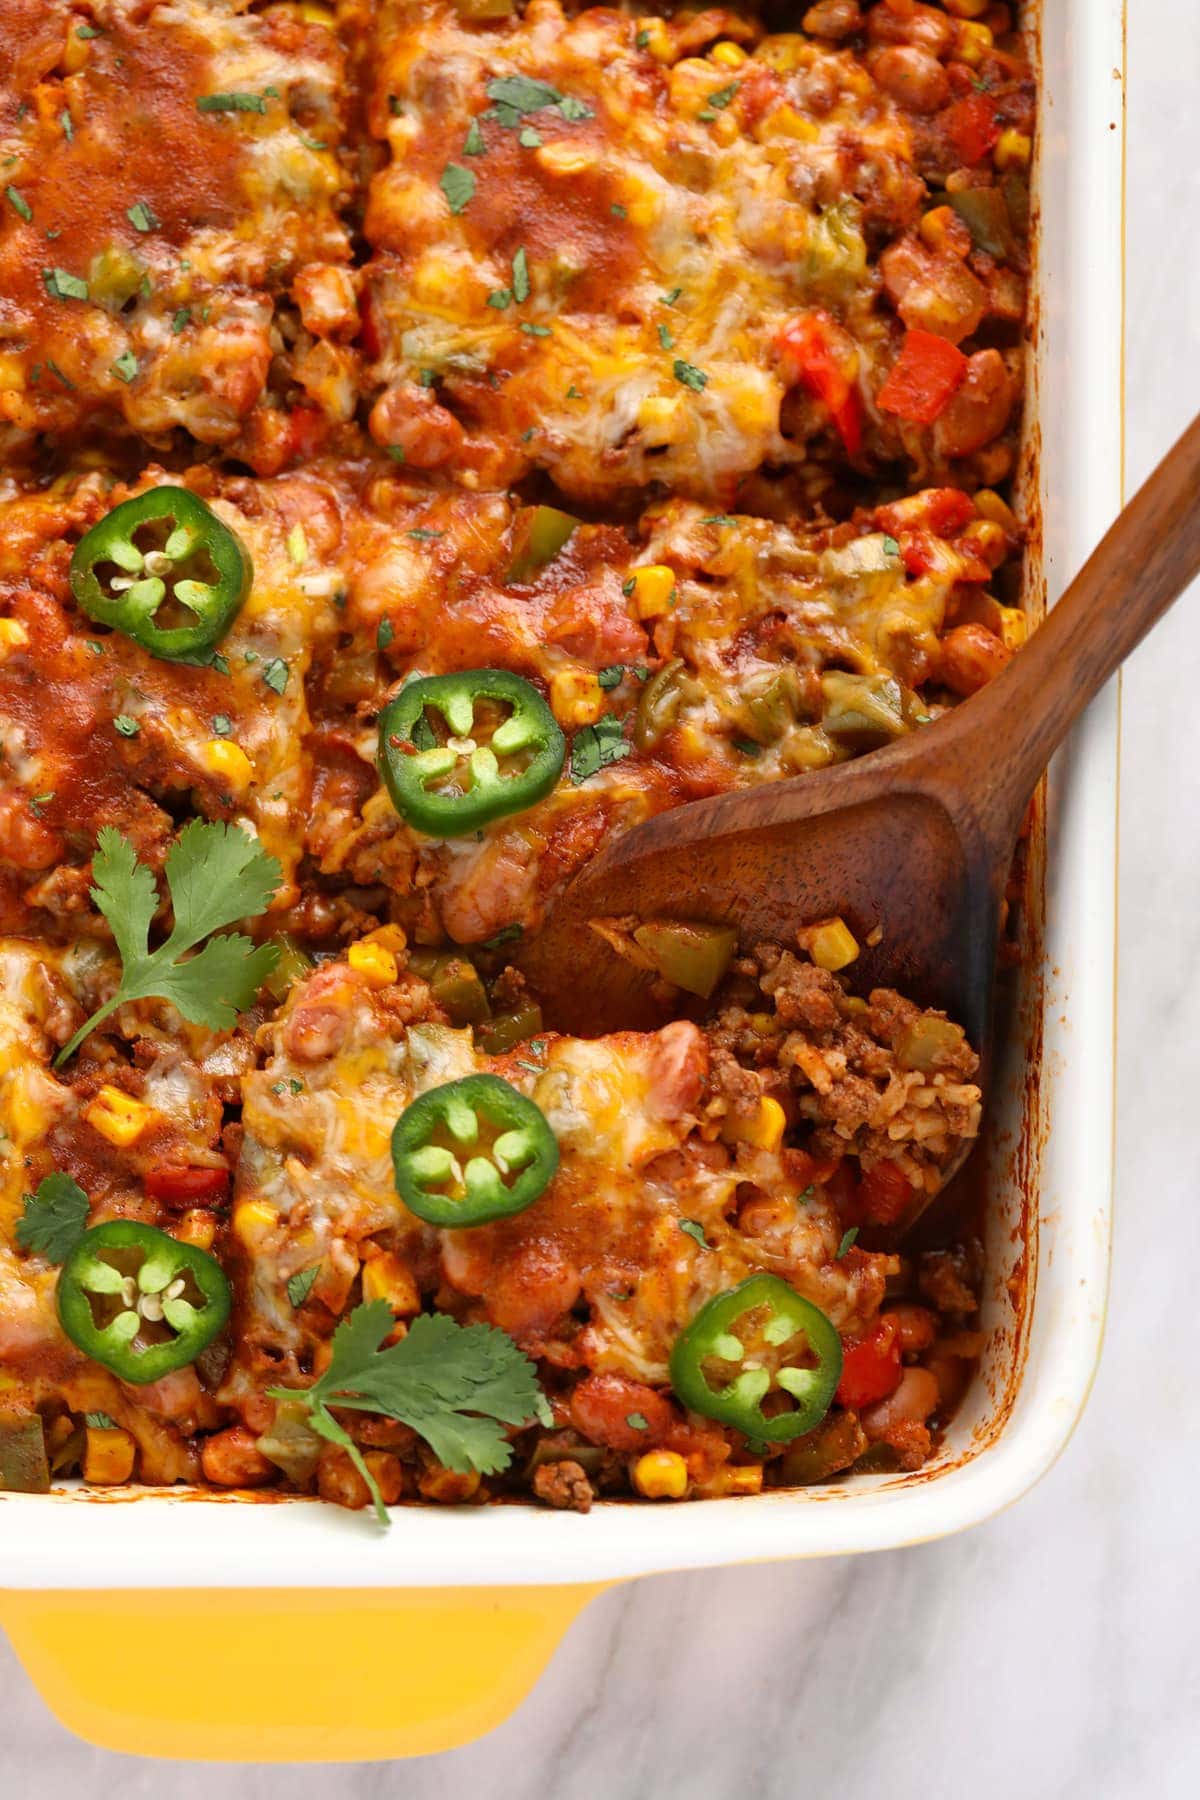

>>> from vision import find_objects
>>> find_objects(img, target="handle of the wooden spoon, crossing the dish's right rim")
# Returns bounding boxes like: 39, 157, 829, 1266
946, 418, 1200, 844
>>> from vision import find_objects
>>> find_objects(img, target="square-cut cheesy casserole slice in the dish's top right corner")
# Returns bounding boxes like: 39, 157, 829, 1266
362, 0, 1033, 511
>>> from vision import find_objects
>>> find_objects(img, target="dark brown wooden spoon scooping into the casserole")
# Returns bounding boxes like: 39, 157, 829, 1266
522, 419, 1200, 1209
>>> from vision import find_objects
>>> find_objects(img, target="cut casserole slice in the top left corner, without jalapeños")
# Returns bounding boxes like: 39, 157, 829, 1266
0, 0, 358, 468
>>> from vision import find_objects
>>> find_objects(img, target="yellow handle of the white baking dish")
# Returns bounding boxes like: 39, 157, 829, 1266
0, 1584, 603, 1762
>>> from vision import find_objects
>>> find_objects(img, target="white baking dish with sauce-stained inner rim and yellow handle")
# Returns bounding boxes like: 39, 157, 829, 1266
0, 0, 1124, 1759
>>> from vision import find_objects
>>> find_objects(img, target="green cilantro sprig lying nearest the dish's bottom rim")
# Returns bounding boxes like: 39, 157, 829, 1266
266, 1300, 552, 1525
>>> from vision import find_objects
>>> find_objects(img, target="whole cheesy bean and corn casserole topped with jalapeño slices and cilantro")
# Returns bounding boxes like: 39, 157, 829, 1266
0, 0, 1033, 1517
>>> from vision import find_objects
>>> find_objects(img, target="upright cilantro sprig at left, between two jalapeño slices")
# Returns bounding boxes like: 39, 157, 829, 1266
54, 819, 282, 1067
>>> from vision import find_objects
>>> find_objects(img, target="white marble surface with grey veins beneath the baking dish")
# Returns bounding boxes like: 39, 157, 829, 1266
0, 0, 1200, 1800
